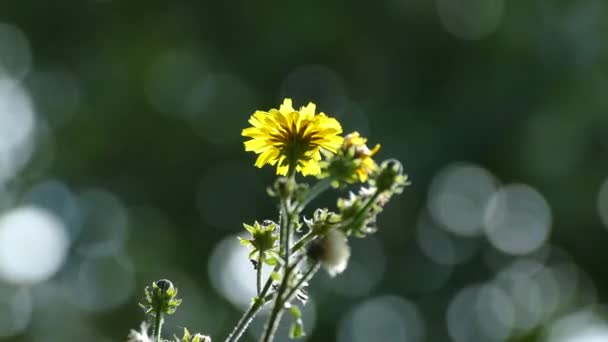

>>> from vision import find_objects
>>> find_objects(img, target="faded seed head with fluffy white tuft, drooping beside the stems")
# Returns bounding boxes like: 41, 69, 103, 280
308, 229, 350, 277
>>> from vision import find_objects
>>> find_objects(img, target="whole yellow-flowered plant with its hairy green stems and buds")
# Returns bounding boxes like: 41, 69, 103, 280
128, 99, 409, 342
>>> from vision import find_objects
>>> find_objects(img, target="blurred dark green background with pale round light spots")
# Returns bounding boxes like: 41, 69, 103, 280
0, 0, 608, 342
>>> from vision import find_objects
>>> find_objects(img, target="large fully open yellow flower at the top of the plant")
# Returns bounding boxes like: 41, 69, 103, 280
242, 99, 343, 176
